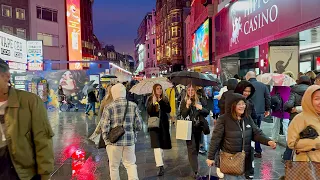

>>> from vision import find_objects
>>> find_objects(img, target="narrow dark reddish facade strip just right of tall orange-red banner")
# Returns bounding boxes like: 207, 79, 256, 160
80, 0, 95, 65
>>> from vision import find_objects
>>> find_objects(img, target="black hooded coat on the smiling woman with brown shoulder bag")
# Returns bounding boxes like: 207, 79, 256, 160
208, 93, 271, 171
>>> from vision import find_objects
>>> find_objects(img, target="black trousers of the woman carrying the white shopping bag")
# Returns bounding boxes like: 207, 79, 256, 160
186, 131, 202, 173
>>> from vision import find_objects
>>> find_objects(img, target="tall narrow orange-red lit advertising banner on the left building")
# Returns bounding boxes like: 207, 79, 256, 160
66, 0, 82, 70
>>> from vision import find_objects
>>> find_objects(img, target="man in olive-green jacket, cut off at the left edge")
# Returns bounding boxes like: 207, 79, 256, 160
0, 59, 54, 180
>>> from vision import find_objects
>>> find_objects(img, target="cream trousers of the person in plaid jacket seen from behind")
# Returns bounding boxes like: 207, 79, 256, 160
106, 145, 139, 180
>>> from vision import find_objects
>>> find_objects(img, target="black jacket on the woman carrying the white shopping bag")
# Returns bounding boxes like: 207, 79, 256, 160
180, 99, 210, 134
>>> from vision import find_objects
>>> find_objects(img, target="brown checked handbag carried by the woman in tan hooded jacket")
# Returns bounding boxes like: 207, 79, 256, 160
285, 139, 320, 180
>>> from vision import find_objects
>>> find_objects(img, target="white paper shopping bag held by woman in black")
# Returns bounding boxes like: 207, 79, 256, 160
176, 120, 192, 140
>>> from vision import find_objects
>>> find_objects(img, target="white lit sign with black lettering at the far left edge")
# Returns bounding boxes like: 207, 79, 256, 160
0, 31, 27, 64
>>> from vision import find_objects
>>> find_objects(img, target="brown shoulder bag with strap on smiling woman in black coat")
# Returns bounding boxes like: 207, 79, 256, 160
220, 120, 246, 176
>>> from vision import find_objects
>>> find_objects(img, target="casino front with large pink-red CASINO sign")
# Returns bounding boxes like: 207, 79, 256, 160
215, 0, 320, 79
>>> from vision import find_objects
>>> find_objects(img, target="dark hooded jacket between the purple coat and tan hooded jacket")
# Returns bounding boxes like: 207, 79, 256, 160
283, 76, 310, 116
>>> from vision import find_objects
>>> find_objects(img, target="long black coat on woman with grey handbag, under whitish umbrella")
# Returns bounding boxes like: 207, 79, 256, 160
147, 97, 172, 149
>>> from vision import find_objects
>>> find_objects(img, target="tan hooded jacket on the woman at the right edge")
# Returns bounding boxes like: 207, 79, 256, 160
287, 85, 320, 162
